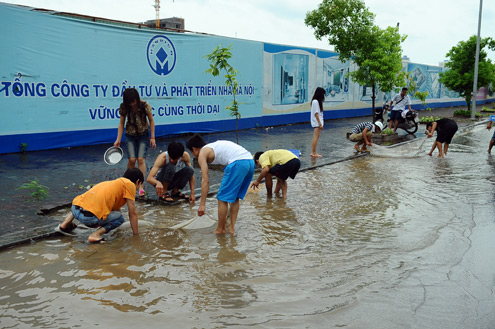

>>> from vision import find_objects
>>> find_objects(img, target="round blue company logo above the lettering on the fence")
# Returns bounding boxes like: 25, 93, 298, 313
147, 35, 177, 75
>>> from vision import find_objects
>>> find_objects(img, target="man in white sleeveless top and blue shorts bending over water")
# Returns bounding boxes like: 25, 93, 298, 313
186, 135, 254, 234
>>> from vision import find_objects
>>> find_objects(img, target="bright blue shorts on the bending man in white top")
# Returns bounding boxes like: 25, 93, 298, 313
217, 160, 254, 203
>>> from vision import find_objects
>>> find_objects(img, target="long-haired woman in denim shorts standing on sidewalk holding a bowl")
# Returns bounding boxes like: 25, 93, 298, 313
113, 88, 156, 195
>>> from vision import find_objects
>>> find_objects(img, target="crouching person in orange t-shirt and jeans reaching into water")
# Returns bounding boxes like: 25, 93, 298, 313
55, 168, 144, 243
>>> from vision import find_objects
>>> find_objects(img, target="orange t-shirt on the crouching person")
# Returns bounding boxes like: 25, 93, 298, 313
72, 177, 136, 220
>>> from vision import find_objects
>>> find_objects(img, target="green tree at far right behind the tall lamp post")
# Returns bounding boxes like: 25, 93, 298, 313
439, 35, 495, 111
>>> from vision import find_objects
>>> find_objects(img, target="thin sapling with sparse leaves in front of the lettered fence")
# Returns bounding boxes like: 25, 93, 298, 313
204, 45, 241, 144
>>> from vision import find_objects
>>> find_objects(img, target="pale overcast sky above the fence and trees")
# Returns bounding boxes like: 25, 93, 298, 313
0, 0, 495, 65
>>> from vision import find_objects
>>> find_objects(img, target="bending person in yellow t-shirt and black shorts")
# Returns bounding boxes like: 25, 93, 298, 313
251, 150, 301, 199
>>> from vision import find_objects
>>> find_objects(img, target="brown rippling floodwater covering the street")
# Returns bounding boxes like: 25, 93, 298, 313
0, 126, 495, 329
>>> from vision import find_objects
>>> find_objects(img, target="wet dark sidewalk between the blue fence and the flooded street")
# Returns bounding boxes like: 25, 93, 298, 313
0, 108, 472, 249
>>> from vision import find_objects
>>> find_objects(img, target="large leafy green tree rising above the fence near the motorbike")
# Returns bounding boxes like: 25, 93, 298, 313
304, 0, 406, 119
